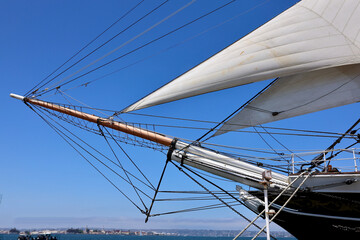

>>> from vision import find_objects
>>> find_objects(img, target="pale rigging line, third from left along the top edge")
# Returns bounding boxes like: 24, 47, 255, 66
40, 0, 196, 95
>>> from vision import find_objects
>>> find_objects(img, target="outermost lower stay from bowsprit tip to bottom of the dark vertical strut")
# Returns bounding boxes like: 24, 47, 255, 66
25, 102, 144, 213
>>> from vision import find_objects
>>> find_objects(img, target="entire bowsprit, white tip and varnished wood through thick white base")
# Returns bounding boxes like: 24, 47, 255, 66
10, 94, 288, 189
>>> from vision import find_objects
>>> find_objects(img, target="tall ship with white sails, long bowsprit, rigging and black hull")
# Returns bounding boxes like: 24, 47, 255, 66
11, 0, 360, 239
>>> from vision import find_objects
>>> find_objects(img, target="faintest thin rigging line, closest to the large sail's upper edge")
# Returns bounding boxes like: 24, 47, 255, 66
58, 0, 270, 94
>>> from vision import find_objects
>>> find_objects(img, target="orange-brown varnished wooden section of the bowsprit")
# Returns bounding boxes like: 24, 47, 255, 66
23, 98, 173, 146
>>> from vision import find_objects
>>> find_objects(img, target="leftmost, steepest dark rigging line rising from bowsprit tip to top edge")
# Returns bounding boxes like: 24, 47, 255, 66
24, 0, 144, 97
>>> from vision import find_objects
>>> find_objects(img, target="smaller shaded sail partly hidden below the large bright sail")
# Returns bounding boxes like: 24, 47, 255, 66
215, 64, 360, 135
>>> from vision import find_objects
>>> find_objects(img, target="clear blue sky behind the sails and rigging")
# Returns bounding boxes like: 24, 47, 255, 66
0, 0, 358, 232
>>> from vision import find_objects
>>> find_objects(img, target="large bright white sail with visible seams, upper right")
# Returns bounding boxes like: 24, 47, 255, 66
123, 0, 360, 112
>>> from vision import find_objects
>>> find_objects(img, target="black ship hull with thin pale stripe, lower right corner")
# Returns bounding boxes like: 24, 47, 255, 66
252, 191, 360, 239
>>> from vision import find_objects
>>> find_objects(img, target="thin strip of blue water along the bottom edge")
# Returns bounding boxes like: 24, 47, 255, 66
0, 234, 296, 240
